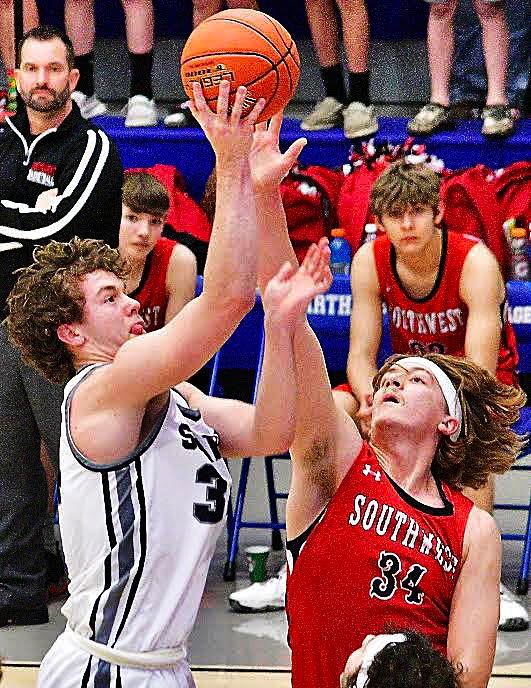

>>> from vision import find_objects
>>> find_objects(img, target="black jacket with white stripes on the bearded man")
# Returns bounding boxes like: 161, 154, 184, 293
0, 103, 123, 312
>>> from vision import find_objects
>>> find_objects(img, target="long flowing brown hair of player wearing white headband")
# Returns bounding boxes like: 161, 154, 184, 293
373, 354, 526, 489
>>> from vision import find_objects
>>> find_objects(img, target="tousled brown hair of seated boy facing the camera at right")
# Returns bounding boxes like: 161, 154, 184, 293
371, 160, 441, 220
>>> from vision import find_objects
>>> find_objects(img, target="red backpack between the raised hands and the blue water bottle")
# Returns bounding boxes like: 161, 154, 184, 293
280, 165, 343, 262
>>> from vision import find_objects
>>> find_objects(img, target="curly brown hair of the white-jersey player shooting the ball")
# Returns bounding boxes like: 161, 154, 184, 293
5, 237, 128, 383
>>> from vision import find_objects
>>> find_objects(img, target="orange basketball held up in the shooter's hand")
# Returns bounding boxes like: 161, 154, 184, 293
181, 10, 300, 122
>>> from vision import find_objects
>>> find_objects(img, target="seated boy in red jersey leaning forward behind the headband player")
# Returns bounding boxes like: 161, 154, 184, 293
334, 160, 528, 631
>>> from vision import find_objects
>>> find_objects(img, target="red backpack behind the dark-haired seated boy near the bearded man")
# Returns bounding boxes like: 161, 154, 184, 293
125, 163, 212, 242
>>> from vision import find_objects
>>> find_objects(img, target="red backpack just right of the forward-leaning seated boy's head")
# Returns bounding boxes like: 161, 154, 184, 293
441, 165, 511, 280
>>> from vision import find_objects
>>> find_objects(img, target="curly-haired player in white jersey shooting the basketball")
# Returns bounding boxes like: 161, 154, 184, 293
7, 83, 331, 688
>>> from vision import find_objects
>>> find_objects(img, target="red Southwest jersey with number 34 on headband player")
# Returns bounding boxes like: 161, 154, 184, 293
286, 444, 472, 688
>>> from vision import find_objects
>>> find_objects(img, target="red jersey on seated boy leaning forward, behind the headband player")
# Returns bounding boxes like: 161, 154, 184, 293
373, 232, 518, 384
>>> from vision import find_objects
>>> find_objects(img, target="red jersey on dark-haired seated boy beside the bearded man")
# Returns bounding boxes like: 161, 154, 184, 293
129, 239, 177, 332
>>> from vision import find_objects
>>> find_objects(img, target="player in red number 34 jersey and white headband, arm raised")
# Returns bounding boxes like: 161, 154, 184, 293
250, 117, 525, 688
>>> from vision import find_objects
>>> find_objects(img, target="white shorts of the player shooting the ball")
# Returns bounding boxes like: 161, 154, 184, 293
37, 633, 195, 688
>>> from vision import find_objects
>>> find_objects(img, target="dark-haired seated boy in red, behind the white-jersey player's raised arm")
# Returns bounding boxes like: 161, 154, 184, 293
119, 172, 197, 332
